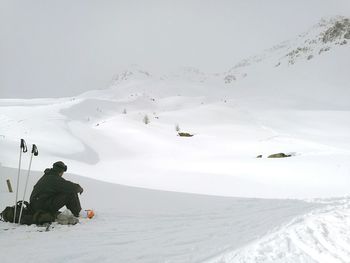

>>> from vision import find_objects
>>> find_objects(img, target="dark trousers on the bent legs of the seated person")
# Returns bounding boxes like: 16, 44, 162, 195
31, 193, 81, 217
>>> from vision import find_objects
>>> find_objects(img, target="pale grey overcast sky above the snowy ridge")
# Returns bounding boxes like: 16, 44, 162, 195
0, 0, 350, 98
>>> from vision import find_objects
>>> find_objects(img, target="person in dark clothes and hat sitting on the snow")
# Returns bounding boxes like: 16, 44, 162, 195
30, 161, 84, 217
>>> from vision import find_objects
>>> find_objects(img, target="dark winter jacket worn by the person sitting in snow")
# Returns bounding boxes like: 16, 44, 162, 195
30, 169, 81, 203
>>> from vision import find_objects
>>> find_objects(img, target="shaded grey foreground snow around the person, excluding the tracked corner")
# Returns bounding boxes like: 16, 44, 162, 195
0, 168, 320, 263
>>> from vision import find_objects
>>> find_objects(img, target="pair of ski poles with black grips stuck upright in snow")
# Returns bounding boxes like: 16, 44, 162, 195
13, 139, 39, 224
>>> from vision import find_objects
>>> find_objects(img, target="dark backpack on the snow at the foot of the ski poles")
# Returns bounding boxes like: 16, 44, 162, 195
0, 201, 33, 225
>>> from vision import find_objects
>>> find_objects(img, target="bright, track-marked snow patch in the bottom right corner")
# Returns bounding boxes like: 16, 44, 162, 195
206, 197, 350, 263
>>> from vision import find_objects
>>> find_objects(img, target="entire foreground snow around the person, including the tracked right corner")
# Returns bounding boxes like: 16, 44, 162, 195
0, 167, 350, 263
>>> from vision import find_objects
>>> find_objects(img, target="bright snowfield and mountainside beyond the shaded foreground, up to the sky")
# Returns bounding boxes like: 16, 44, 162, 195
0, 17, 350, 198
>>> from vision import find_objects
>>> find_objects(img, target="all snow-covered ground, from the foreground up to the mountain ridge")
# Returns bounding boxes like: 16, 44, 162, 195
0, 17, 350, 263
